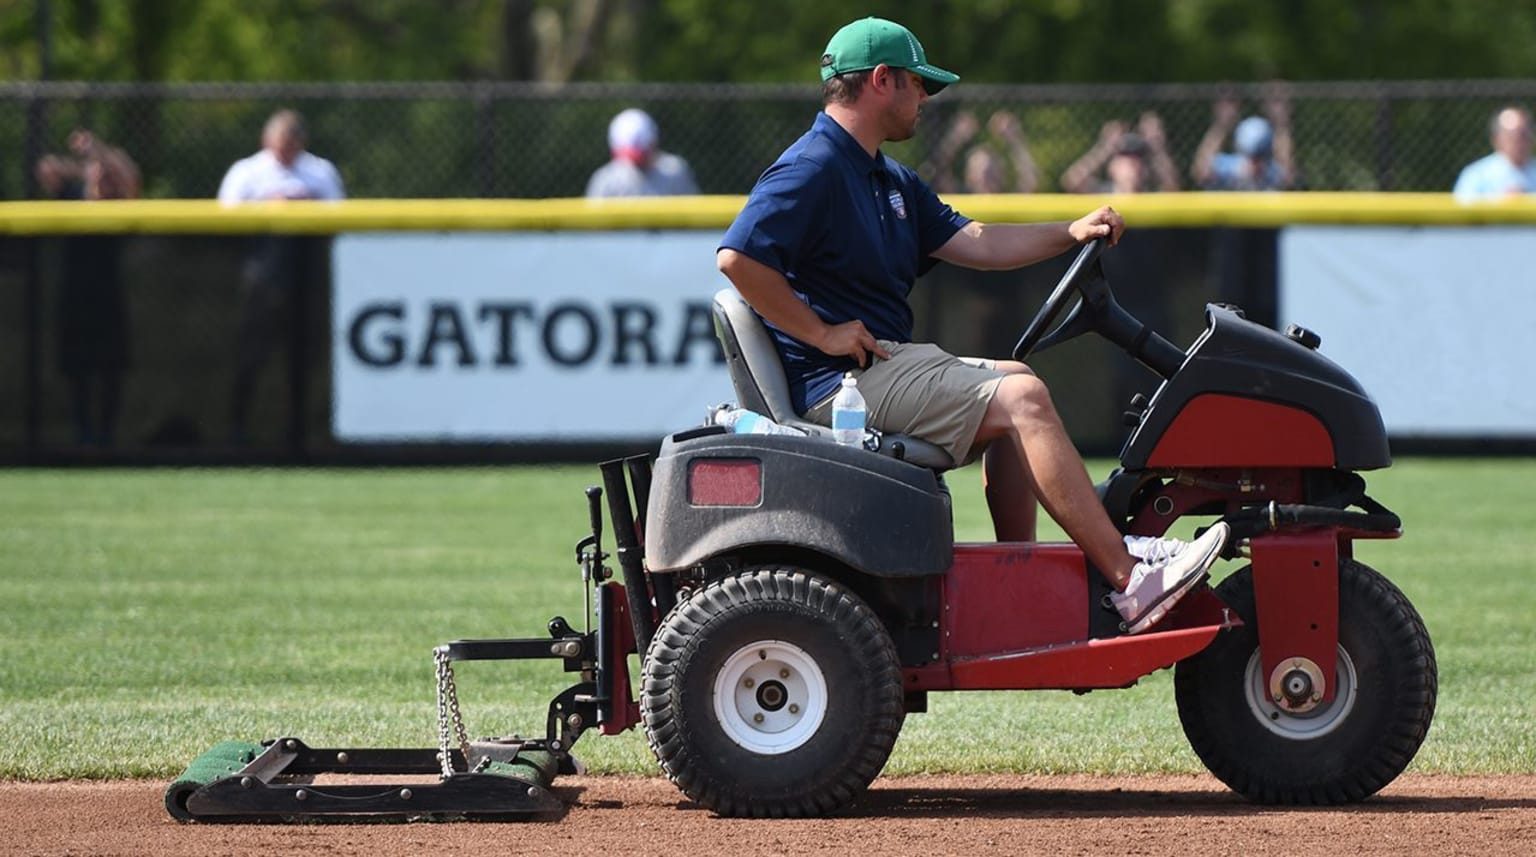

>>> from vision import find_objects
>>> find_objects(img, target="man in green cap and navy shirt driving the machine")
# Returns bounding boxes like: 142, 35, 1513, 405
717, 18, 1229, 633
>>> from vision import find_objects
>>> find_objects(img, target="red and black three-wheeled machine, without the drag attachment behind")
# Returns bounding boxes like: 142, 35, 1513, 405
610, 274, 1436, 814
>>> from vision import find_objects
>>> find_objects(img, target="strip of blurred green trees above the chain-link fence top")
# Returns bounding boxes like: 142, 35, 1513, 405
9, 0, 1536, 83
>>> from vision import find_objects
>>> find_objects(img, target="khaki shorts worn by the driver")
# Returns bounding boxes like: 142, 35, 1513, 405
805, 339, 1006, 467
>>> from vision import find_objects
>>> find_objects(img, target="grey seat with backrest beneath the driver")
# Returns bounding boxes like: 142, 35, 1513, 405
713, 289, 954, 470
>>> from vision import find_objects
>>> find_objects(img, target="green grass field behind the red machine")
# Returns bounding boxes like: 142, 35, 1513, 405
0, 459, 1536, 780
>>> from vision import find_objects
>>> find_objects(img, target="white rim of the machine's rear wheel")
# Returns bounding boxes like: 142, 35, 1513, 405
714, 640, 826, 756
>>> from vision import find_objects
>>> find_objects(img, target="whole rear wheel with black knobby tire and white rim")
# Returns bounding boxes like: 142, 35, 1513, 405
641, 568, 905, 817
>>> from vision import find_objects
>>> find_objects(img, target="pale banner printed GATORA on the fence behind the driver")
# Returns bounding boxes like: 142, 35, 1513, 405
332, 232, 734, 442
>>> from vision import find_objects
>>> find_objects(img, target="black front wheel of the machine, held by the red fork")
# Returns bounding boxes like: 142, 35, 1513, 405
1174, 561, 1438, 805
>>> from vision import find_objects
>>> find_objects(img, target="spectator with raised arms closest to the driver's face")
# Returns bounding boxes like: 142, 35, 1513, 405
925, 111, 1040, 194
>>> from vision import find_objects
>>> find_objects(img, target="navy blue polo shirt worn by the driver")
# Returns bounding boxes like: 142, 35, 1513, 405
720, 112, 971, 413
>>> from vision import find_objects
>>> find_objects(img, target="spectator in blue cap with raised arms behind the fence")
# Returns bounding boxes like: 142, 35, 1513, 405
1190, 91, 1296, 190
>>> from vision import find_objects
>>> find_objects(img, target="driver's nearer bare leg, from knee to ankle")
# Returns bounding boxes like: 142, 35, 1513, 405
977, 373, 1137, 590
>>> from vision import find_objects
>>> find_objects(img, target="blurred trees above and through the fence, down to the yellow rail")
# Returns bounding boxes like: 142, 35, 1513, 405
0, 0, 1536, 198
